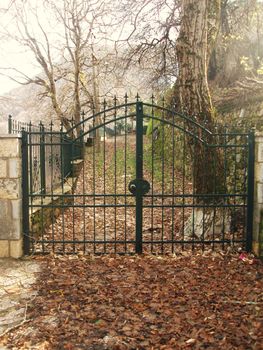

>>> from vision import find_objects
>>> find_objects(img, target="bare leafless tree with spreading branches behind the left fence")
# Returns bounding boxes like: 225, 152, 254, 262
0, 0, 110, 135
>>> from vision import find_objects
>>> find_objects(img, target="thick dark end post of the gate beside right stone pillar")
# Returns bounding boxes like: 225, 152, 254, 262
246, 130, 255, 251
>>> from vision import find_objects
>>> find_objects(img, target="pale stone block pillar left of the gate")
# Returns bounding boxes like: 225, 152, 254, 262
0, 135, 23, 259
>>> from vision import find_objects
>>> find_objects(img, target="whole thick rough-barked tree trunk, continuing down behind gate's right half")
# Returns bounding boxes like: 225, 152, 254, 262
175, 0, 227, 236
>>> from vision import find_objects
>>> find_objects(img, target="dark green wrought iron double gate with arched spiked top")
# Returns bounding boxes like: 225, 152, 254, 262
20, 96, 254, 254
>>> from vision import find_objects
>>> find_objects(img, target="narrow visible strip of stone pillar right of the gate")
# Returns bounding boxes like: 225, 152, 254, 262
253, 133, 263, 257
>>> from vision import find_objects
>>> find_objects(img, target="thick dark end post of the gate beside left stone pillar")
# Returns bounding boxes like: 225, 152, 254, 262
22, 130, 30, 255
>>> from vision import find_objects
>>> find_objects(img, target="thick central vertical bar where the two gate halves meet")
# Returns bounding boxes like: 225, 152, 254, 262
135, 101, 143, 254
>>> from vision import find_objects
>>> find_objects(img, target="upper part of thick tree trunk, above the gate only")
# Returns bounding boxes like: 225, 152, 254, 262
176, 0, 216, 121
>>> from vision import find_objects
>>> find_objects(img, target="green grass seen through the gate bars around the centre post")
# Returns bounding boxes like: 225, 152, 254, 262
92, 127, 190, 191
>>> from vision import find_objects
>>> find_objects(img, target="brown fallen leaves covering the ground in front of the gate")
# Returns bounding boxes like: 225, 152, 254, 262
2, 253, 263, 350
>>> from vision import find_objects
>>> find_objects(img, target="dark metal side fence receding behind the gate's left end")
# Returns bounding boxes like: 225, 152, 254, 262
8, 116, 82, 194
